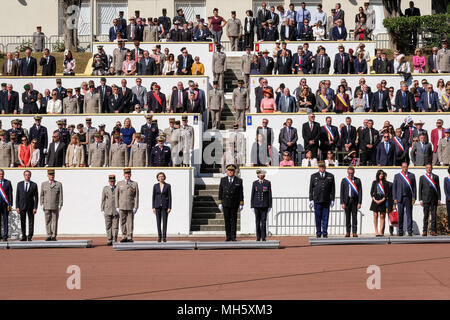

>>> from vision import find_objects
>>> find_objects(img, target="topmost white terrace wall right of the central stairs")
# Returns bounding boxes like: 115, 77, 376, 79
255, 41, 376, 73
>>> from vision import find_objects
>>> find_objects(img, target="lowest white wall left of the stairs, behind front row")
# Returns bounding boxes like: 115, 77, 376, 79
5, 168, 194, 237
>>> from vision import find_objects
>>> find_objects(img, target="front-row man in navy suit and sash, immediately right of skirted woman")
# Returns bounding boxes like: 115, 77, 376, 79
392, 162, 417, 237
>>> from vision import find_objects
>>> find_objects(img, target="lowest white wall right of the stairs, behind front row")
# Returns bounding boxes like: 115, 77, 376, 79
240, 167, 447, 235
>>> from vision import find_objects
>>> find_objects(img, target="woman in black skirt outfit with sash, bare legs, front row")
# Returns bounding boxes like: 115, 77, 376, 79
370, 170, 392, 237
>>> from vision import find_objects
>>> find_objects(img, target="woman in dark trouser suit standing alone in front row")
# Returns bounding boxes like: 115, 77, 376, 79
152, 172, 172, 242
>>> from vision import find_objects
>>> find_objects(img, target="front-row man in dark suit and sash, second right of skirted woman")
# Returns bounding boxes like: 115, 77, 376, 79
419, 163, 441, 237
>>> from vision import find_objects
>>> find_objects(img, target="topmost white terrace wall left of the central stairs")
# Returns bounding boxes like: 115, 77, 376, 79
93, 41, 215, 77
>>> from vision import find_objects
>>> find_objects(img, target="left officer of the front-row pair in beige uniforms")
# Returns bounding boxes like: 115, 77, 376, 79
101, 174, 119, 246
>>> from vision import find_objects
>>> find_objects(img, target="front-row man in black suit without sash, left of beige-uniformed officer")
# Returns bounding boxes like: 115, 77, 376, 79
16, 170, 39, 241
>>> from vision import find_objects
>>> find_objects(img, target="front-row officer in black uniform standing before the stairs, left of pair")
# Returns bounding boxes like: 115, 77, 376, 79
218, 164, 244, 241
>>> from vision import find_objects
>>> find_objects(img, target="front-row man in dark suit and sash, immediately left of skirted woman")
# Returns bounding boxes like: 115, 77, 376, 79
340, 167, 362, 238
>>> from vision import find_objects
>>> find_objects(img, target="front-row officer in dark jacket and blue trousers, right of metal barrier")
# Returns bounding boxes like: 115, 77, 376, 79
309, 161, 336, 238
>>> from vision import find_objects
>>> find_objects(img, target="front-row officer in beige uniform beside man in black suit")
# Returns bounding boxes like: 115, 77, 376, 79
40, 169, 63, 241
